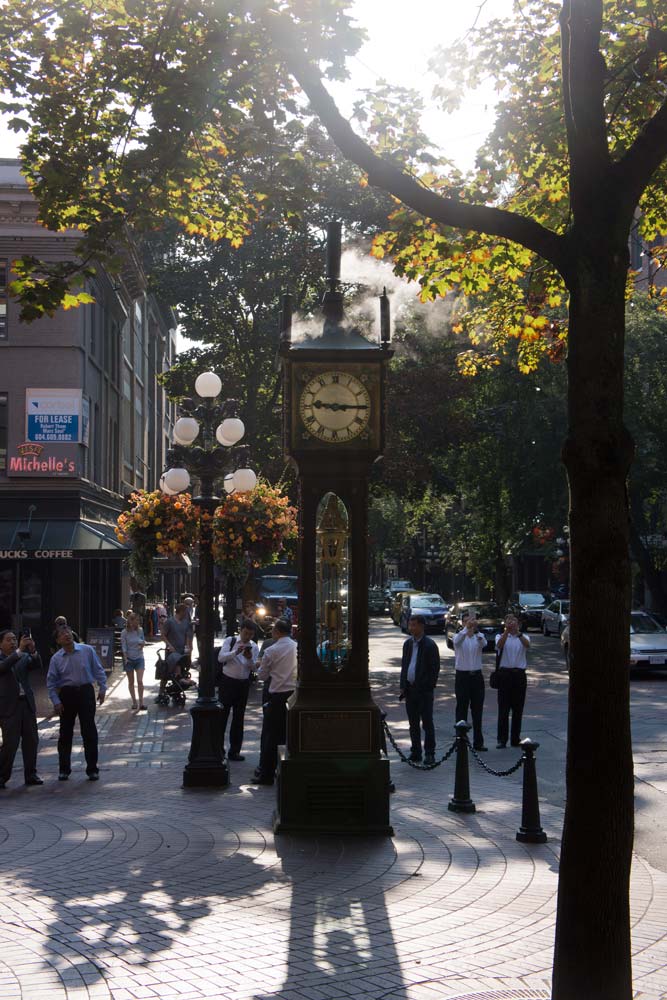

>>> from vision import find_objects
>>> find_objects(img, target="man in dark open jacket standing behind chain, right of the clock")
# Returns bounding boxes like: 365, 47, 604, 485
401, 615, 440, 764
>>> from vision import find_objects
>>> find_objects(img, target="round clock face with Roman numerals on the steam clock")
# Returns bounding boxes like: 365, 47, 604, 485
299, 371, 371, 444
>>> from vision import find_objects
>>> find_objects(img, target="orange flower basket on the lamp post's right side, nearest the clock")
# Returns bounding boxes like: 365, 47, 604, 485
213, 482, 297, 577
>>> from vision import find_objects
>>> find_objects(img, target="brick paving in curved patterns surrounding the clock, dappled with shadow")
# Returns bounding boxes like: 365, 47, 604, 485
0, 649, 667, 1000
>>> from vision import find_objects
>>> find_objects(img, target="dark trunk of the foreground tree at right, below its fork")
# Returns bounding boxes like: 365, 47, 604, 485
553, 250, 634, 1000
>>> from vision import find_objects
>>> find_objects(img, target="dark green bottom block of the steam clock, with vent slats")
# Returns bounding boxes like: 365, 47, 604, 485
273, 754, 394, 837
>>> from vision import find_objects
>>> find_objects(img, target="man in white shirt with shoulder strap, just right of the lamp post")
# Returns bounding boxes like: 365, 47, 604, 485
218, 621, 259, 760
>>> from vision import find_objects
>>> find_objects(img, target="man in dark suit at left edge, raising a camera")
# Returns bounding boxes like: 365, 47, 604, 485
0, 629, 44, 788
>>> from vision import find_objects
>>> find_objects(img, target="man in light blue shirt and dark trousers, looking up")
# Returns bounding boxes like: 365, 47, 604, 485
46, 625, 107, 781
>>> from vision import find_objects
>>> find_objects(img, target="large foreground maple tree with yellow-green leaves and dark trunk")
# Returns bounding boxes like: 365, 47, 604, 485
0, 0, 667, 1000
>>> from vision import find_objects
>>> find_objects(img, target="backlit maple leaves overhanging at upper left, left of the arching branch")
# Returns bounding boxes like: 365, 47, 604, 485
0, 0, 360, 319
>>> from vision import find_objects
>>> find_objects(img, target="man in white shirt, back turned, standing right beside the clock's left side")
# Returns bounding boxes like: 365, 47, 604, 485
252, 618, 297, 785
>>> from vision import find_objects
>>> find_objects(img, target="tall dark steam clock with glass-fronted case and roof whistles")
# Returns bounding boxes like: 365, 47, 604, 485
274, 223, 393, 834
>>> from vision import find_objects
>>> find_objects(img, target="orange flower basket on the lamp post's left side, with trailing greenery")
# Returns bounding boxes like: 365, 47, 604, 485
116, 490, 200, 587
